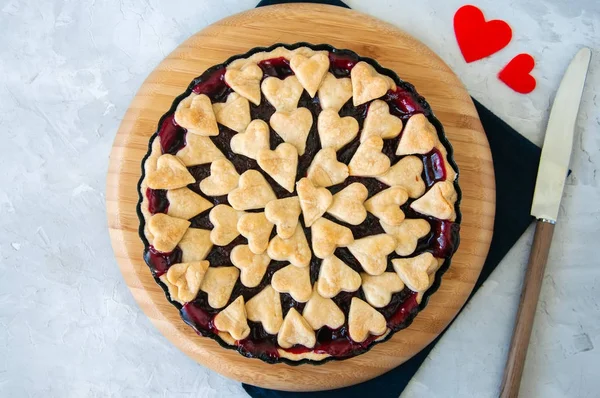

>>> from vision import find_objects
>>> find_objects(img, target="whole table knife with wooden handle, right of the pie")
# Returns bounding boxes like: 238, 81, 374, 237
500, 48, 591, 398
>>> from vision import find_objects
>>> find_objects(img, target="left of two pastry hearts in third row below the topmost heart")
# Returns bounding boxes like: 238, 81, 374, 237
269, 108, 312, 156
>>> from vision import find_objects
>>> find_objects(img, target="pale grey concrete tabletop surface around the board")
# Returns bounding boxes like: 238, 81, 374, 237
0, 0, 600, 398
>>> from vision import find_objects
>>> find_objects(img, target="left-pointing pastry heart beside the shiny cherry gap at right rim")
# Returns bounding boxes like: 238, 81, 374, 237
376, 156, 425, 198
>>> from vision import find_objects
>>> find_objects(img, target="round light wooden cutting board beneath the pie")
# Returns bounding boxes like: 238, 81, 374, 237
106, 4, 496, 391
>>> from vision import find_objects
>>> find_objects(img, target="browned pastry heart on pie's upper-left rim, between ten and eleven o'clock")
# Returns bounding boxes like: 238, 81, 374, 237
175, 93, 219, 136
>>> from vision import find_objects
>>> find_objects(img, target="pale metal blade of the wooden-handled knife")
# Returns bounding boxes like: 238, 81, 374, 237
531, 48, 591, 223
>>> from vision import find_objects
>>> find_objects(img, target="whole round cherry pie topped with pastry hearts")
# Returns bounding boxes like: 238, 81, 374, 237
139, 43, 460, 364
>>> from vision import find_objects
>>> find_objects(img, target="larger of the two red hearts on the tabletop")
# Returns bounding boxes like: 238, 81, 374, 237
454, 5, 512, 62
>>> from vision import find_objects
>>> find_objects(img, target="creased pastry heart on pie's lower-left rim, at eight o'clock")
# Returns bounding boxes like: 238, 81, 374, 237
165, 261, 209, 304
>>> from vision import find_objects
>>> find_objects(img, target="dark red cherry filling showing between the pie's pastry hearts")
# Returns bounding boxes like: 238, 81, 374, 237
145, 51, 459, 362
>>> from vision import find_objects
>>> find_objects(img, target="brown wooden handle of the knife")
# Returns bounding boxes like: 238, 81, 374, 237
500, 220, 554, 398
